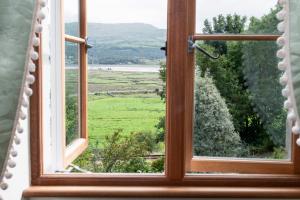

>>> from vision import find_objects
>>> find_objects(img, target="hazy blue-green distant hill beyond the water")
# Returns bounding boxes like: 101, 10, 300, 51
65, 23, 166, 64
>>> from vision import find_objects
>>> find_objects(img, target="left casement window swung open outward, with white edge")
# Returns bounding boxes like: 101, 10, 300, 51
47, 0, 88, 171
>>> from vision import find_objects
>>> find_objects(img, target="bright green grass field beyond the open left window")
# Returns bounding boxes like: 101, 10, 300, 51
88, 94, 165, 146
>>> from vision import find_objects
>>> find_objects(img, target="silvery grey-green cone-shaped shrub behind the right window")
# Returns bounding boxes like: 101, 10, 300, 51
194, 75, 241, 157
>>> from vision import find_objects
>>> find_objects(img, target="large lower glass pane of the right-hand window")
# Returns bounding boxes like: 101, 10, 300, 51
193, 41, 291, 160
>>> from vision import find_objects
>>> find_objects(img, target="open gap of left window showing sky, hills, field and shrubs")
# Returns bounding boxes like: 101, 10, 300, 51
73, 0, 167, 173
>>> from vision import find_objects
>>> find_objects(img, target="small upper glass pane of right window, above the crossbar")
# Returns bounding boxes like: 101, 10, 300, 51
196, 0, 280, 34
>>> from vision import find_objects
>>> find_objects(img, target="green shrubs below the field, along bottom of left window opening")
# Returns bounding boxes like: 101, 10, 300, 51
76, 130, 164, 173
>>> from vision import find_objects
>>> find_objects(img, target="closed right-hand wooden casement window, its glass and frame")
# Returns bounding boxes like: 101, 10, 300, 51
187, 0, 299, 174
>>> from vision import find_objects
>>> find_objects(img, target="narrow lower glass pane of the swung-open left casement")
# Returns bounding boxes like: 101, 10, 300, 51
65, 42, 80, 145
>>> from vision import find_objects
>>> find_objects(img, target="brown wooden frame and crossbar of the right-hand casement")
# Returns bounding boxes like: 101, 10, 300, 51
186, 34, 300, 174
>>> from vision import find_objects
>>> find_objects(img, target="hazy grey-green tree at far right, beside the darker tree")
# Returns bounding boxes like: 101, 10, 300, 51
242, 6, 286, 146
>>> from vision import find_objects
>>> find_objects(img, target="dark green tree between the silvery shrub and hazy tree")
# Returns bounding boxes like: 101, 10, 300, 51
197, 12, 276, 151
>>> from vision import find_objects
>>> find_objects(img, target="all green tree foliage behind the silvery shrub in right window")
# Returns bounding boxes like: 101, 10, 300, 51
197, 8, 285, 150
